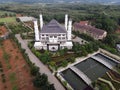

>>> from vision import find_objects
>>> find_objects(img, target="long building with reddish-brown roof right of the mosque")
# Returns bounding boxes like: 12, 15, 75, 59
73, 22, 107, 40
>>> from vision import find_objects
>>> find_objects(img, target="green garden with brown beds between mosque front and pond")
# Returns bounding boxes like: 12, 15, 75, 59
28, 39, 98, 70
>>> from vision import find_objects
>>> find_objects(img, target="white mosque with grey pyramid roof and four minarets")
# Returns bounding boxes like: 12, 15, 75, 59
34, 14, 73, 51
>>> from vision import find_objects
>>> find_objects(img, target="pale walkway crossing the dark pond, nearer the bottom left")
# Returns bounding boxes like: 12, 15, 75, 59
70, 66, 92, 85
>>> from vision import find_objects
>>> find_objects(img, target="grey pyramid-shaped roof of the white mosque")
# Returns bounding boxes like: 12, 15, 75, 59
40, 19, 67, 33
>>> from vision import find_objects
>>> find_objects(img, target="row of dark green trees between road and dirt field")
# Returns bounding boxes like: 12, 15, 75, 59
10, 33, 55, 90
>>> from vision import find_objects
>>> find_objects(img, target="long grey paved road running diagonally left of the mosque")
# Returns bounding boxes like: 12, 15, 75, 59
15, 34, 65, 90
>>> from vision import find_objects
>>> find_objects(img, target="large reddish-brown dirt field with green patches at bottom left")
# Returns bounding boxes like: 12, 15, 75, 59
0, 39, 36, 90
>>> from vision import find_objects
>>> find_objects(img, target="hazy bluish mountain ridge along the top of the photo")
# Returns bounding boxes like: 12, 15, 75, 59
0, 0, 120, 4
